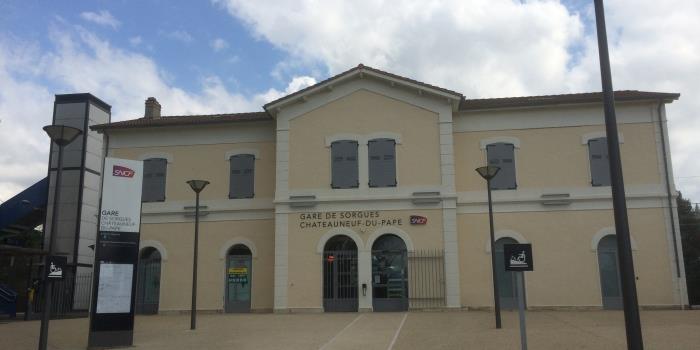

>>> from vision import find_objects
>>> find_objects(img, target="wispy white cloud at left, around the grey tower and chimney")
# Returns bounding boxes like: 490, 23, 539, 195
0, 26, 308, 200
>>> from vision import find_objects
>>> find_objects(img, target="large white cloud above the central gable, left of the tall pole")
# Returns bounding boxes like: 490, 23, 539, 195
215, 0, 583, 96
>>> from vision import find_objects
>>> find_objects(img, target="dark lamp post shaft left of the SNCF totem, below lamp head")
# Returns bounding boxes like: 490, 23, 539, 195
39, 143, 63, 350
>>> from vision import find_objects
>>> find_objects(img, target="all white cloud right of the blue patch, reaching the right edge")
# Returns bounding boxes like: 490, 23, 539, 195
214, 0, 700, 201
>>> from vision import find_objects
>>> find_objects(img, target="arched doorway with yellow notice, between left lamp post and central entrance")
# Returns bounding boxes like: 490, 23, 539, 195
224, 244, 253, 312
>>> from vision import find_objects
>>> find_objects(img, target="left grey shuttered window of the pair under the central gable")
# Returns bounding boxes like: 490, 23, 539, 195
331, 140, 359, 188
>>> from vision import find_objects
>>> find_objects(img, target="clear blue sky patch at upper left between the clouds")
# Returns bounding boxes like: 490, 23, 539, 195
0, 0, 296, 100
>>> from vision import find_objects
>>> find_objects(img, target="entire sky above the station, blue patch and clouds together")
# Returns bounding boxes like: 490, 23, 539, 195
0, 0, 700, 201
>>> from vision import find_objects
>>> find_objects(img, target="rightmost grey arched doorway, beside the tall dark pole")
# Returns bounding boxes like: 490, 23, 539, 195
598, 235, 622, 310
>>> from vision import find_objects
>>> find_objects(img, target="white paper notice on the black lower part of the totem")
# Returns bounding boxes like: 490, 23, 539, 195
96, 263, 134, 314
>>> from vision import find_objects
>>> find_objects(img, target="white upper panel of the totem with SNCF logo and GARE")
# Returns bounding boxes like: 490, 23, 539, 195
100, 158, 143, 232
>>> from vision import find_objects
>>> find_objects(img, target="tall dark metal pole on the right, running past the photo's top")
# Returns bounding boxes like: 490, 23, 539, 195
594, 0, 644, 350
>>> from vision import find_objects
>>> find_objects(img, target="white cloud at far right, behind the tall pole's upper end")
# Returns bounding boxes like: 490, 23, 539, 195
570, 0, 700, 201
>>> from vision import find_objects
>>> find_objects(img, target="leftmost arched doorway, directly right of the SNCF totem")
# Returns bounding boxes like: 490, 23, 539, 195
134, 247, 161, 314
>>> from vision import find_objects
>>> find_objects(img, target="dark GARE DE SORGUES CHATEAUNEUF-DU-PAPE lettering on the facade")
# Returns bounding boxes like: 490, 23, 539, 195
299, 210, 405, 229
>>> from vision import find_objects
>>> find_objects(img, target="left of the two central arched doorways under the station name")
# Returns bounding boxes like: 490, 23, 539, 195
322, 235, 357, 312
